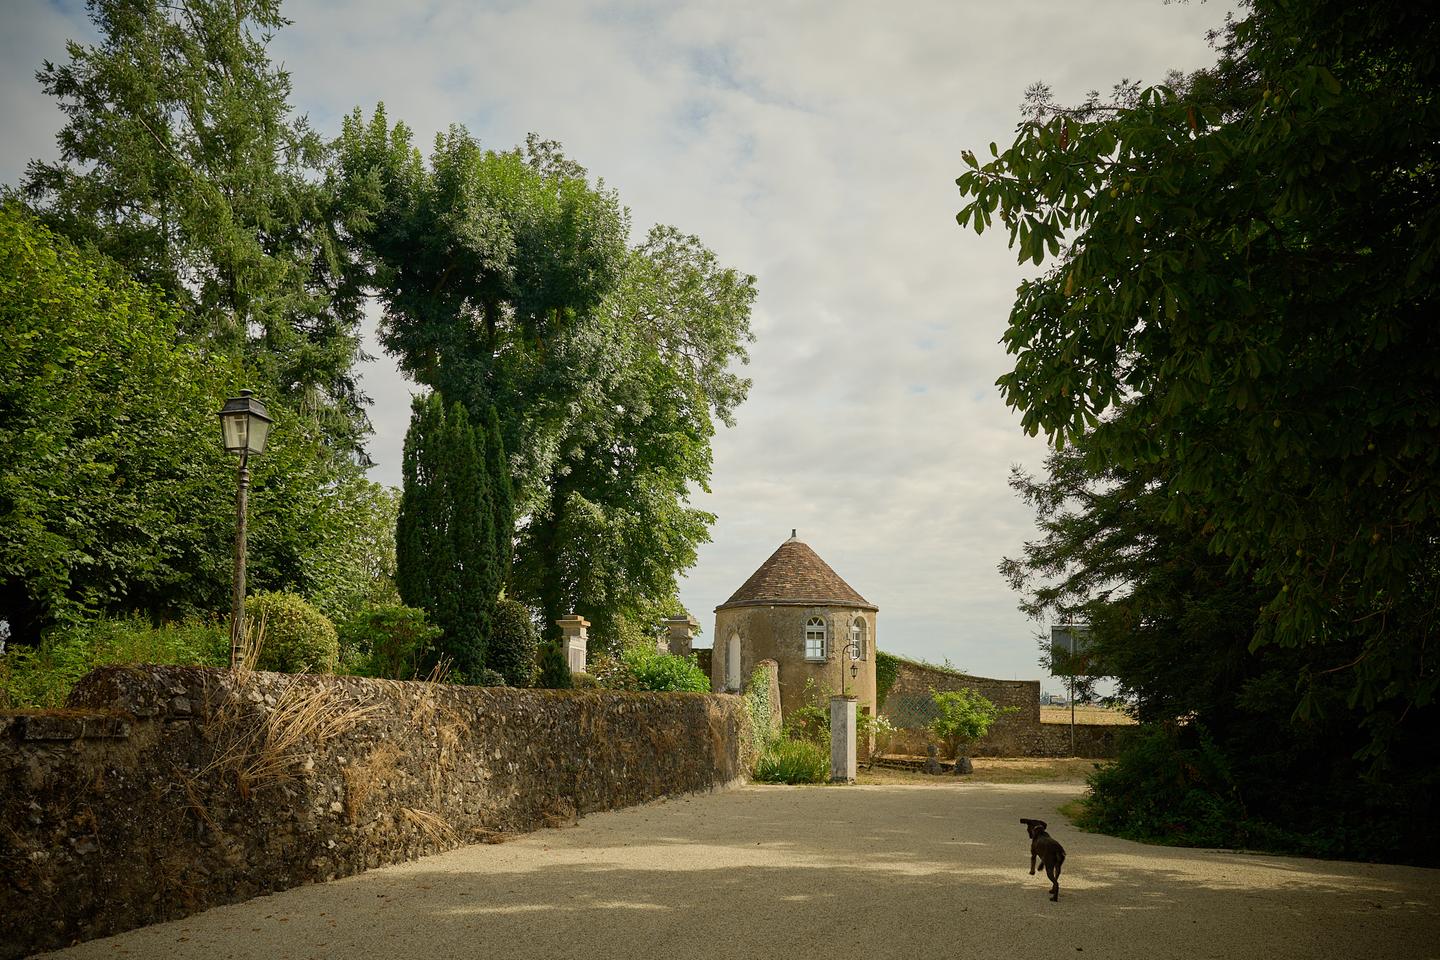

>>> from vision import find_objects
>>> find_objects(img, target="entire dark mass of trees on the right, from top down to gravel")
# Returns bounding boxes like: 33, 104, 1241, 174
984, 0, 1440, 864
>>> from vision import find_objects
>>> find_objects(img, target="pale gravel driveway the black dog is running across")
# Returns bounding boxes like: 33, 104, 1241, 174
39, 783, 1440, 960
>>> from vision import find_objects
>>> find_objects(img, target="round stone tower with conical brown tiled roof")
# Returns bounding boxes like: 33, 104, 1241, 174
710, 531, 880, 715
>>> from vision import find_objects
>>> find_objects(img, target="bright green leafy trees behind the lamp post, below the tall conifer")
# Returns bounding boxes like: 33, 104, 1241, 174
0, 203, 369, 643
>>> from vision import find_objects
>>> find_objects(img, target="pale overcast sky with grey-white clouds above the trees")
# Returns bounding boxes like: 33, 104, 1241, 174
0, 0, 1228, 689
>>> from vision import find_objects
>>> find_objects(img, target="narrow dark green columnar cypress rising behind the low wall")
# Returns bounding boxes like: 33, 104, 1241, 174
395, 393, 503, 681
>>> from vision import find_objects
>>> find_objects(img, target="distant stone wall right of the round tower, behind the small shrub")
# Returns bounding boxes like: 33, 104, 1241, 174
880, 659, 1129, 759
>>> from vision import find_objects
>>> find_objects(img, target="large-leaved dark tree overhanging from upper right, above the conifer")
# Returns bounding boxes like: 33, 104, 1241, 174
958, 0, 1440, 759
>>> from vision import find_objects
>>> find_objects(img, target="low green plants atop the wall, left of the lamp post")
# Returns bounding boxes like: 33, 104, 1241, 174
0, 616, 230, 710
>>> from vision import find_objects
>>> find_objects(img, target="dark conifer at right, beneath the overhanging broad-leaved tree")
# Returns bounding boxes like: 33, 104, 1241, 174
1001, 428, 1440, 862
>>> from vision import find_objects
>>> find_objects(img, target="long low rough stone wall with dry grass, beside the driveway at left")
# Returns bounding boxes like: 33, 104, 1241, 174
0, 666, 749, 960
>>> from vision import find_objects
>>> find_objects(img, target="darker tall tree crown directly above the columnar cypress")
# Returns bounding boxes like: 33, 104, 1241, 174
336, 114, 629, 503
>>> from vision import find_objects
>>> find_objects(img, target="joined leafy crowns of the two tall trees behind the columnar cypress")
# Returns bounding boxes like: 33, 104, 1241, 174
336, 108, 755, 652
